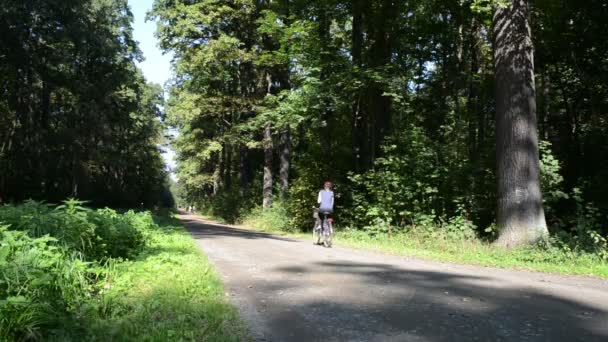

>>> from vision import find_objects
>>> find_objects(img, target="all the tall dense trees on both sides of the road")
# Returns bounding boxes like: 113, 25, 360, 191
0, 0, 608, 250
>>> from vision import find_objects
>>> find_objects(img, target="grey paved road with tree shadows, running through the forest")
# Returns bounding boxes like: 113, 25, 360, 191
181, 215, 608, 342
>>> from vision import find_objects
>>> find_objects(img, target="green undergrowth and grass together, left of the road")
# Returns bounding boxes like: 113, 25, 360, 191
0, 200, 245, 341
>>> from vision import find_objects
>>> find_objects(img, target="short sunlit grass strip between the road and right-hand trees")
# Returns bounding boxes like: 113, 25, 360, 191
230, 210, 608, 279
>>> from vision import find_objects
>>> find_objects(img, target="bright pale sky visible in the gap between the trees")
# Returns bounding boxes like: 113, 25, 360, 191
129, 0, 177, 180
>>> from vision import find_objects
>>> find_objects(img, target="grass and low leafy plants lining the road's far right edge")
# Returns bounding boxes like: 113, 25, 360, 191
234, 202, 608, 279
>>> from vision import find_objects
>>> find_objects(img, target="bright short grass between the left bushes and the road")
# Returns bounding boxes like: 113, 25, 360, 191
83, 220, 247, 341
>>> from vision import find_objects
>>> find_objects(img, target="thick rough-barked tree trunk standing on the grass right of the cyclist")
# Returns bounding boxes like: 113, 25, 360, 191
493, 0, 548, 247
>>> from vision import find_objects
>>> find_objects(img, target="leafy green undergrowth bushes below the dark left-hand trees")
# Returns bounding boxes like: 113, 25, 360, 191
0, 200, 157, 341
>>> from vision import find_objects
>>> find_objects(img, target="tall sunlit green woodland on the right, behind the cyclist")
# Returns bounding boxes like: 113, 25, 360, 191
149, 0, 608, 245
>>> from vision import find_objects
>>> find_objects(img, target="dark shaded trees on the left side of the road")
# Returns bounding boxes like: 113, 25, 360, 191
0, 0, 170, 207
